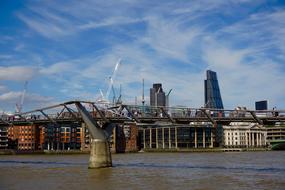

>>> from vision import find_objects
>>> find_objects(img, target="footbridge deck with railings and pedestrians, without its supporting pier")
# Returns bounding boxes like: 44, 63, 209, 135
0, 101, 285, 126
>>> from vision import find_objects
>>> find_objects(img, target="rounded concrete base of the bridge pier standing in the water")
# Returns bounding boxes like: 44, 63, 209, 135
88, 139, 112, 168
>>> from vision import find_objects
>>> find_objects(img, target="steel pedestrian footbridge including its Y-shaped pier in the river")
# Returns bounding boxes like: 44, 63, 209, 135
0, 100, 285, 168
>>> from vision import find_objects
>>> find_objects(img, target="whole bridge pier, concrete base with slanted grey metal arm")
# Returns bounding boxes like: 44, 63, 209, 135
75, 102, 112, 168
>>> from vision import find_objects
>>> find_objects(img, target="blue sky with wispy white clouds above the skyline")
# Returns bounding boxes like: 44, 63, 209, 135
0, 0, 285, 112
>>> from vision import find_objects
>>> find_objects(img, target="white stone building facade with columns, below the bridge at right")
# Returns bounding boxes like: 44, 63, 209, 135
223, 122, 267, 148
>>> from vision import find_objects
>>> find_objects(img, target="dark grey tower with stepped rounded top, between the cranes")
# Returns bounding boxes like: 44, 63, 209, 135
150, 83, 165, 106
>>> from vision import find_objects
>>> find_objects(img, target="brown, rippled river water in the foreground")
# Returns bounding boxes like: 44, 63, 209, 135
0, 151, 285, 190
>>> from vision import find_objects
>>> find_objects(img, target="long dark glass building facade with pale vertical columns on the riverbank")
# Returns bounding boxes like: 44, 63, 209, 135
139, 125, 215, 149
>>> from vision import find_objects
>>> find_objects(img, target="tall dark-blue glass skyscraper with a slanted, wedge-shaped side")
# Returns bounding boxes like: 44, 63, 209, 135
204, 70, 224, 109
